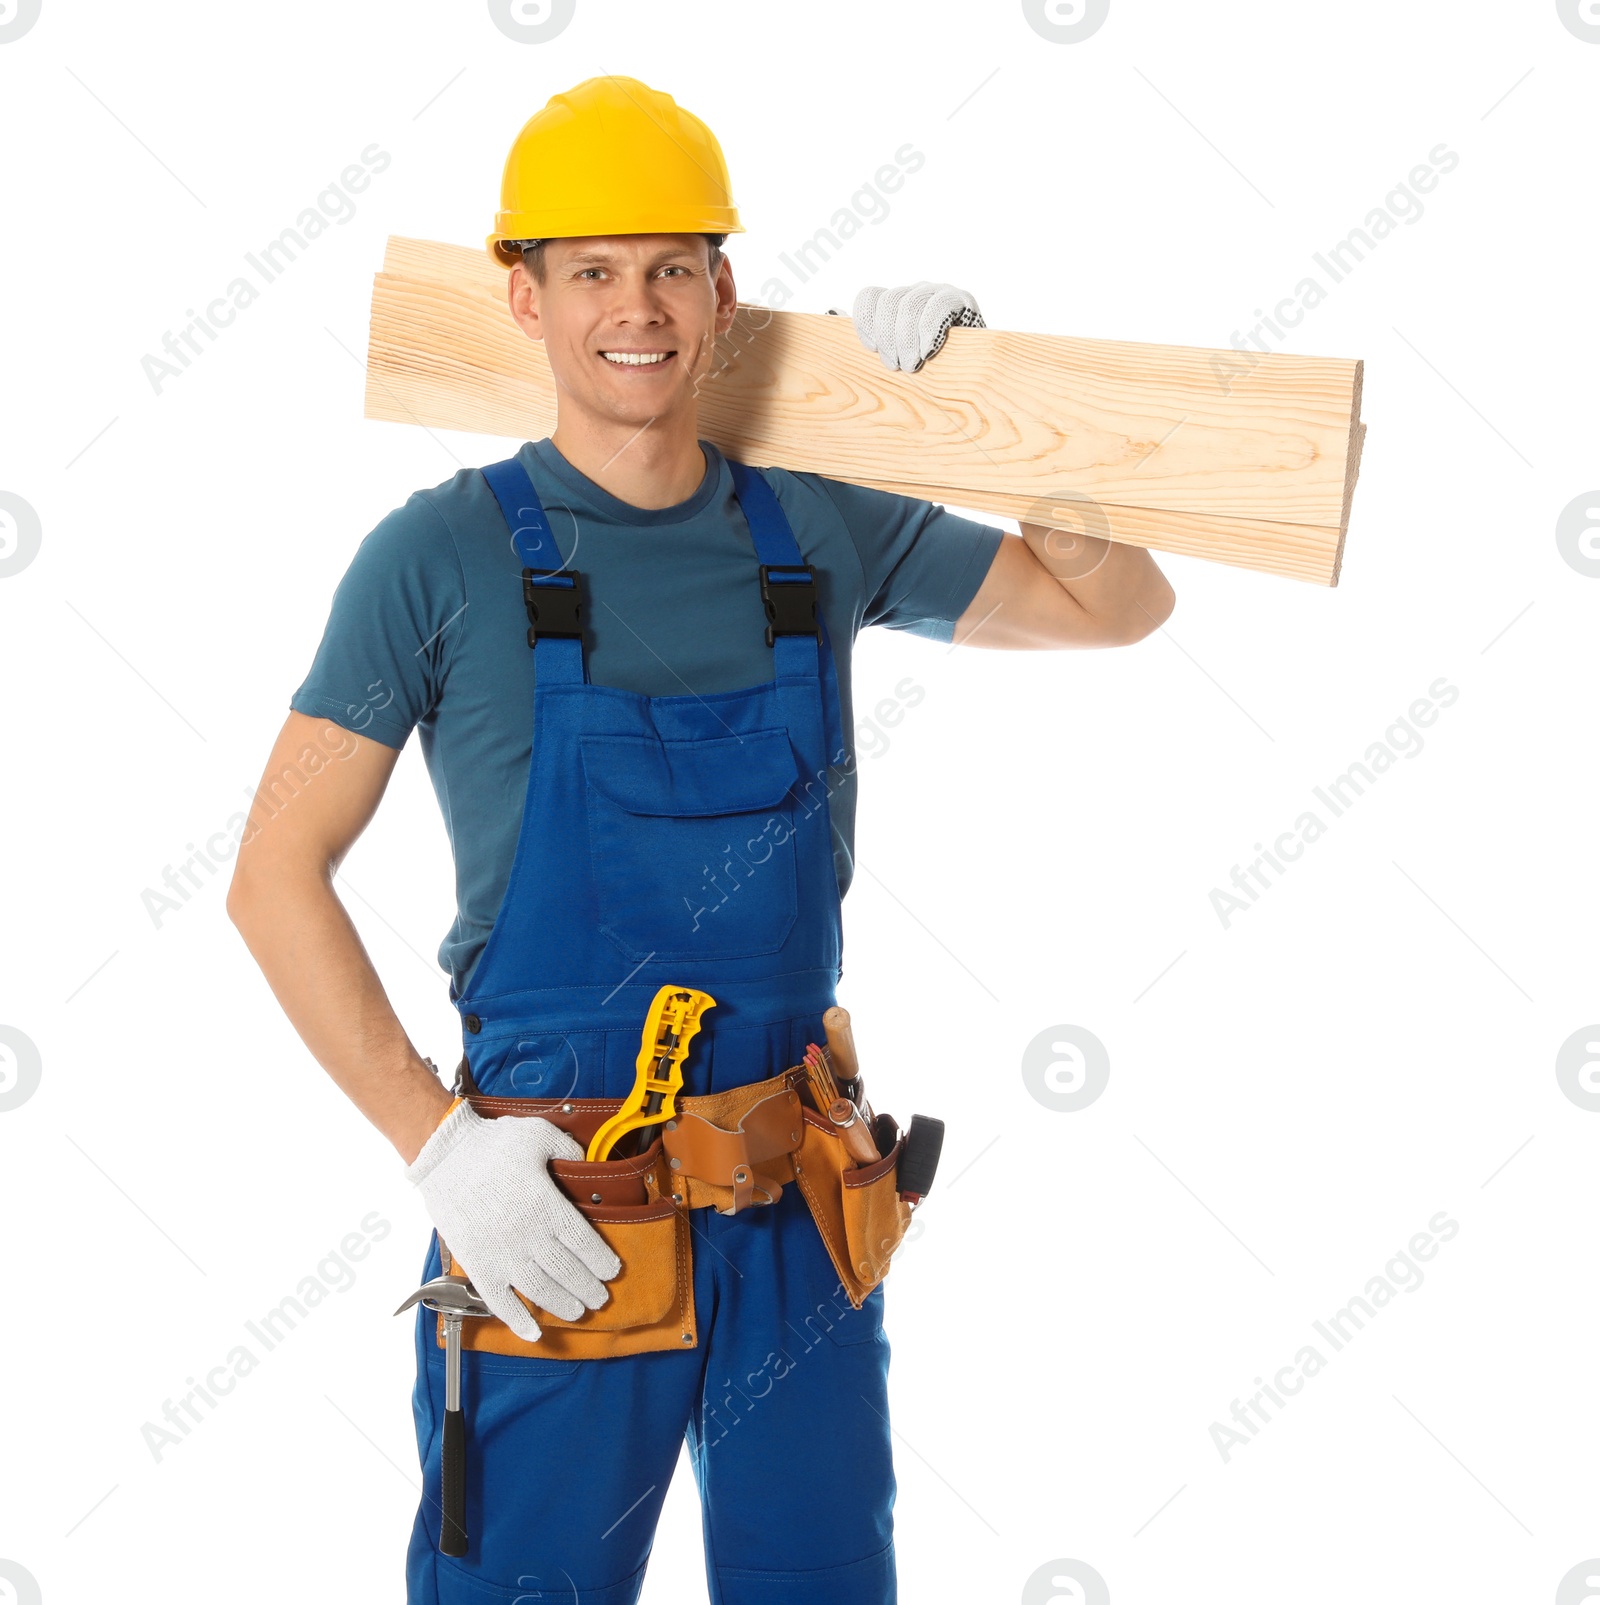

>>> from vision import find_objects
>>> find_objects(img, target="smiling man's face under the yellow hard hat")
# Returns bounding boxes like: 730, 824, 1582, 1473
509, 234, 735, 427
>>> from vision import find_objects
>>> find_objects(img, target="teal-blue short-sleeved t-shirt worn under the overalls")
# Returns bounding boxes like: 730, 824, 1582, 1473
289, 440, 1001, 992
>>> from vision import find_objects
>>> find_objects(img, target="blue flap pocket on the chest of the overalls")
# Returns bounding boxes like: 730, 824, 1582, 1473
581, 729, 799, 960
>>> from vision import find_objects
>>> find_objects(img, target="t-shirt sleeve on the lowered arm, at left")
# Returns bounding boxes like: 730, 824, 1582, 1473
289, 494, 467, 746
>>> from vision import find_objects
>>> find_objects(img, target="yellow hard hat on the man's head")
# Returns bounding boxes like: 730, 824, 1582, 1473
488, 75, 745, 266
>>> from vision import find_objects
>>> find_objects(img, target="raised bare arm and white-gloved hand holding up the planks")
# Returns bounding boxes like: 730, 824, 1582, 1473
834, 281, 1175, 652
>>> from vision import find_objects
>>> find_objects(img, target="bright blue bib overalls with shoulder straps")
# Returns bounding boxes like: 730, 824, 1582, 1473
406, 457, 895, 1605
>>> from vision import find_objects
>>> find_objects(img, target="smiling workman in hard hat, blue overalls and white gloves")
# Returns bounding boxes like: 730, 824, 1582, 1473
228, 79, 1173, 1605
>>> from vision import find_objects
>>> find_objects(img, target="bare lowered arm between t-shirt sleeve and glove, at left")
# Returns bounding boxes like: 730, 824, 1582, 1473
228, 713, 451, 1165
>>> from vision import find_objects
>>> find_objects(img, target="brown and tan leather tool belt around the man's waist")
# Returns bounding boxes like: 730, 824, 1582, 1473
438, 1064, 912, 1359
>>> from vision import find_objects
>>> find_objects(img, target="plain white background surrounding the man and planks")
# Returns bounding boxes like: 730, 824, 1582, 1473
0, 0, 1600, 1605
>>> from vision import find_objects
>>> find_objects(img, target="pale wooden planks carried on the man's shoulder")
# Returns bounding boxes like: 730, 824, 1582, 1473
366, 236, 1362, 584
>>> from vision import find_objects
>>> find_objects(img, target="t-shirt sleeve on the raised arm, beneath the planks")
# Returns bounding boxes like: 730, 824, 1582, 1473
822, 478, 1005, 640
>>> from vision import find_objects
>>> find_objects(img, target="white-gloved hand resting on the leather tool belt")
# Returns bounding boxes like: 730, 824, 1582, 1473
406, 1103, 623, 1343
